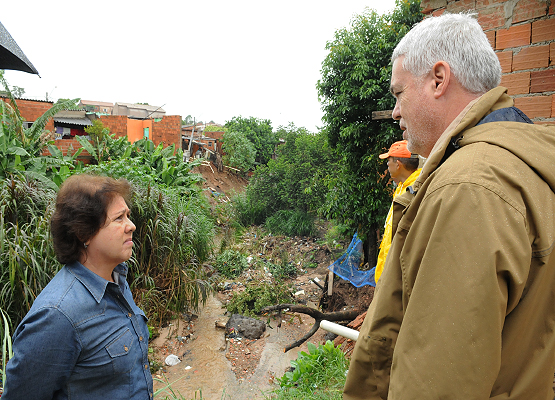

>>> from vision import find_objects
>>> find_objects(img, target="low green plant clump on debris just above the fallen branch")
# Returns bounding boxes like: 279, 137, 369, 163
226, 282, 293, 317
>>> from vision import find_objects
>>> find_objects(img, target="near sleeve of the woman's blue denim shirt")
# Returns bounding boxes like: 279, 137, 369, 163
2, 308, 80, 400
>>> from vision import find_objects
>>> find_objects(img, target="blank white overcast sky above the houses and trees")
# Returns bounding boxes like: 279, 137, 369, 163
0, 0, 395, 132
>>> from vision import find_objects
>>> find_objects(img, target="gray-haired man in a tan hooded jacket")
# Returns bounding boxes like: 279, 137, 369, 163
344, 14, 555, 400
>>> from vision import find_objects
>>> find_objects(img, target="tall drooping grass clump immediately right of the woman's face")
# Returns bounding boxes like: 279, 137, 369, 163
129, 182, 214, 325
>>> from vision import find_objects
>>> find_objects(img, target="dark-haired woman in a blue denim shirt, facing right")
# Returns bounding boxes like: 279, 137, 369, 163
2, 175, 152, 400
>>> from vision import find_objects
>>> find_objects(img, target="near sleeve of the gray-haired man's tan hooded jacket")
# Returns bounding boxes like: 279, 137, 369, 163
388, 182, 531, 400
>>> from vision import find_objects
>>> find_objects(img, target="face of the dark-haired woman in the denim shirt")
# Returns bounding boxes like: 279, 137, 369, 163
86, 195, 135, 268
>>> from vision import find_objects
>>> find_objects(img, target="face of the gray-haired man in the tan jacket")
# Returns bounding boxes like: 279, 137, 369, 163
390, 56, 441, 157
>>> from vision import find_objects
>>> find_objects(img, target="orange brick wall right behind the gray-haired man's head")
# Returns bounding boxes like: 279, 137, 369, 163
421, 0, 555, 124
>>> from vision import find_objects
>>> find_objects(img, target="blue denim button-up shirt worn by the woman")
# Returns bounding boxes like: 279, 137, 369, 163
2, 262, 153, 400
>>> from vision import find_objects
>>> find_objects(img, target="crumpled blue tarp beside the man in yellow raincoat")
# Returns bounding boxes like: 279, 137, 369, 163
328, 233, 376, 287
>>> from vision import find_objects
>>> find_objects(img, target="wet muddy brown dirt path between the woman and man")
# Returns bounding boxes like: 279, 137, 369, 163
152, 297, 325, 400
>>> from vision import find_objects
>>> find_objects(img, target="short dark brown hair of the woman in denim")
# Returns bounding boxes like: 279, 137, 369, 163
50, 174, 131, 264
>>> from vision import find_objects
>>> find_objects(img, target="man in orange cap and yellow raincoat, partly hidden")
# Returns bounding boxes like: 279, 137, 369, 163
374, 140, 421, 286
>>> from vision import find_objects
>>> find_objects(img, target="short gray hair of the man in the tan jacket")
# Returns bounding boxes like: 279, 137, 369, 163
391, 13, 501, 94
